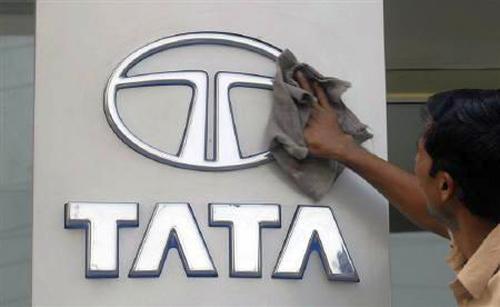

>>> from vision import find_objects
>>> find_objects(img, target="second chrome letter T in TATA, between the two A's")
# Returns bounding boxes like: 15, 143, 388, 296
209, 204, 281, 277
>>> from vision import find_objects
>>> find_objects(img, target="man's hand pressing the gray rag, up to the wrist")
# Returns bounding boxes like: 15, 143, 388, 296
294, 71, 358, 161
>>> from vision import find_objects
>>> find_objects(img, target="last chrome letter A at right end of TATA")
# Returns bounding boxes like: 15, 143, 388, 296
273, 206, 359, 282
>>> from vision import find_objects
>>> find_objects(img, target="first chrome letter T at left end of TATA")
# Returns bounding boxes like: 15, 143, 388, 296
64, 202, 139, 278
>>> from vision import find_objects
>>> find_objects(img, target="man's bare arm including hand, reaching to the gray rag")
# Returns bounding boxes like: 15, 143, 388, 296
296, 72, 448, 238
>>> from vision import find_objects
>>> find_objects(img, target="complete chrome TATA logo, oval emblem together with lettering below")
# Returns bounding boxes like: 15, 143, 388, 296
75, 32, 359, 282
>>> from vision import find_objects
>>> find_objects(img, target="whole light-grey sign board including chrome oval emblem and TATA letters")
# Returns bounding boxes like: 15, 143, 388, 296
32, 1, 390, 306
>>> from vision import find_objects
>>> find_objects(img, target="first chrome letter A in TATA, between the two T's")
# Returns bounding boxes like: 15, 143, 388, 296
129, 203, 217, 277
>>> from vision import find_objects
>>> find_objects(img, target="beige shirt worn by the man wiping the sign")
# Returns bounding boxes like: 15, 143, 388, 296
447, 225, 500, 307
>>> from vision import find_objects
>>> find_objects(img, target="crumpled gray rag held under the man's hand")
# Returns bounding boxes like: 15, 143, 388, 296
266, 50, 372, 200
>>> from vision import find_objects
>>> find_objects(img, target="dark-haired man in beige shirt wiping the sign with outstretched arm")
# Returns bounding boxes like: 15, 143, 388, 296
295, 71, 500, 307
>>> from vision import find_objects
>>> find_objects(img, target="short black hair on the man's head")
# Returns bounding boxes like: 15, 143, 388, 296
424, 89, 500, 224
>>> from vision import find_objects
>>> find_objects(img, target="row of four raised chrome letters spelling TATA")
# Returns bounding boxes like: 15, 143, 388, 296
64, 202, 359, 282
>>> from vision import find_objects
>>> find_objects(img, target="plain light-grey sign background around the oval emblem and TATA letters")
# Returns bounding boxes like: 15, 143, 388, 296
33, 0, 390, 307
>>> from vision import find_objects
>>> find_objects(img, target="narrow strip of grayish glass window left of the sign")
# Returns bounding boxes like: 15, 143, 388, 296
0, 2, 34, 306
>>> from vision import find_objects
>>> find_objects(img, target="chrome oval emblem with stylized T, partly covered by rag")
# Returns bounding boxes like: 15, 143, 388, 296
104, 32, 281, 171
